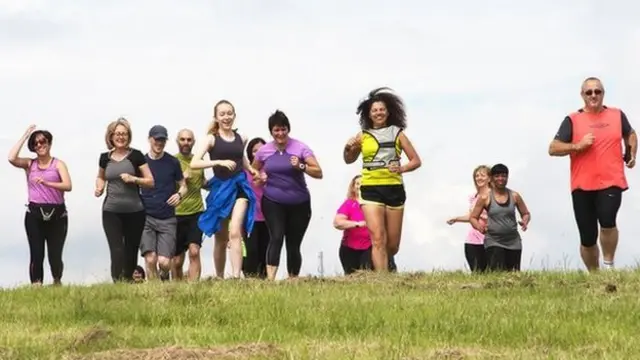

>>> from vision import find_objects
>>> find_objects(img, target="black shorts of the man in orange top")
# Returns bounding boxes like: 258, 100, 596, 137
571, 186, 623, 247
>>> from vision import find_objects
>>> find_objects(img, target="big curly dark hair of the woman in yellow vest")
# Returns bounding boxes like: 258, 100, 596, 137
356, 87, 407, 130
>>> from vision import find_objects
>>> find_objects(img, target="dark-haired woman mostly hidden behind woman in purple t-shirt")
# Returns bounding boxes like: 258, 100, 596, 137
242, 137, 269, 279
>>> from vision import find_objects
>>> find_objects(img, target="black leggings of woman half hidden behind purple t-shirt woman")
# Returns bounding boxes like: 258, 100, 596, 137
242, 221, 269, 279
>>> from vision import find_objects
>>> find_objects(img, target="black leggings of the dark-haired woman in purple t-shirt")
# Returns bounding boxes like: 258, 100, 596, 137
262, 196, 311, 276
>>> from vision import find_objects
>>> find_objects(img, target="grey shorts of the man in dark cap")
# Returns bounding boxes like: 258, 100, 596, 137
140, 215, 178, 258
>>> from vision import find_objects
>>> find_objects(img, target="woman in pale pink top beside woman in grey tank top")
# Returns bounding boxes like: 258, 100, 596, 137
447, 165, 491, 272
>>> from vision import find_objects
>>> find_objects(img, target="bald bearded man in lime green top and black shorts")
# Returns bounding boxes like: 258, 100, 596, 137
173, 129, 206, 281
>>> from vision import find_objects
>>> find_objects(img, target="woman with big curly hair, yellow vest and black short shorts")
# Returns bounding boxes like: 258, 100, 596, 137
343, 88, 422, 271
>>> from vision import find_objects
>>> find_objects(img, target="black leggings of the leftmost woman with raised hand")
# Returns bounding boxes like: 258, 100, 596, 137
24, 205, 69, 284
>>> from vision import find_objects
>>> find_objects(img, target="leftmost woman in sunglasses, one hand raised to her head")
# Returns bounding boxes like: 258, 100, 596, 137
9, 125, 71, 285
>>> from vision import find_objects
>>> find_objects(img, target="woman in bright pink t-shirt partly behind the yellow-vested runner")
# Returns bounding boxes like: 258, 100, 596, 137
333, 175, 372, 275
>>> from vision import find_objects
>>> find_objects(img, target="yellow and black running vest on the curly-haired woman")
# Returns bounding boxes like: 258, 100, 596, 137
361, 125, 402, 185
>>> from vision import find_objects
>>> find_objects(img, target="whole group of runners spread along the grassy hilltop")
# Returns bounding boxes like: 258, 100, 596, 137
9, 78, 637, 284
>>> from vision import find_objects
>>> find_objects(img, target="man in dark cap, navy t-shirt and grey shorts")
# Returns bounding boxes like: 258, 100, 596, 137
140, 125, 187, 281
